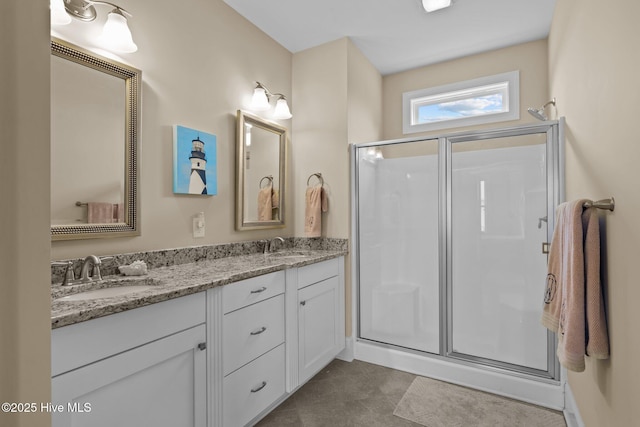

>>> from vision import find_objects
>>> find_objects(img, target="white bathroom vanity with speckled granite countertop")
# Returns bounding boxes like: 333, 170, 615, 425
52, 251, 345, 427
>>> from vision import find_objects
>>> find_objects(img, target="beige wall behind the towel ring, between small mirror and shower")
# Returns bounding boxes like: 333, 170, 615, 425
292, 38, 382, 336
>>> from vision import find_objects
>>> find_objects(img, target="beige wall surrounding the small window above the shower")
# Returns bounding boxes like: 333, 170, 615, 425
382, 40, 548, 139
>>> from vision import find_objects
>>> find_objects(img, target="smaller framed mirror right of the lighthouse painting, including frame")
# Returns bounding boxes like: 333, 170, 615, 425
236, 110, 287, 230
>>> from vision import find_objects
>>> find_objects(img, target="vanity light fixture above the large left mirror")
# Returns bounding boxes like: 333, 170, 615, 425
51, 0, 138, 53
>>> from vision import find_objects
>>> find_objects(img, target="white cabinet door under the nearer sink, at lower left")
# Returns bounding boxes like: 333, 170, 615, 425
52, 325, 207, 427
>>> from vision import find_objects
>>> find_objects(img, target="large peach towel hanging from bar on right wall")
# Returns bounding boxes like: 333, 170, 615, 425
542, 200, 609, 372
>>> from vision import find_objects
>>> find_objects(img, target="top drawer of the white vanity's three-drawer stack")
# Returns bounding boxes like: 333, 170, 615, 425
222, 271, 284, 314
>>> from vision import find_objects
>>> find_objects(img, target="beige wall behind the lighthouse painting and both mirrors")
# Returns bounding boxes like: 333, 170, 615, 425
51, 0, 296, 259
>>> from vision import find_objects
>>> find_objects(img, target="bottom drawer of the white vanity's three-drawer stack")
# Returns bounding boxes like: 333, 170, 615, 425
222, 344, 285, 426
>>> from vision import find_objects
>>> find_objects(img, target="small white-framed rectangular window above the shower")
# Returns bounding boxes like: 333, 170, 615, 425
402, 71, 520, 134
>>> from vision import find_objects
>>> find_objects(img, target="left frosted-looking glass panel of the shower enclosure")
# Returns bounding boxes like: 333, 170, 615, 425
356, 140, 440, 353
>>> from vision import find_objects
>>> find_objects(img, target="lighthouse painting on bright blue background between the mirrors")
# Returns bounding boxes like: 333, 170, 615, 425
173, 125, 218, 196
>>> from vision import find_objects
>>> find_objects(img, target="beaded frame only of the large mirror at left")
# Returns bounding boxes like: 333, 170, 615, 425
51, 38, 142, 240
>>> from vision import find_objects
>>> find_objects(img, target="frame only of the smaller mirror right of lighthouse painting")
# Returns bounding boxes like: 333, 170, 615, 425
236, 110, 287, 230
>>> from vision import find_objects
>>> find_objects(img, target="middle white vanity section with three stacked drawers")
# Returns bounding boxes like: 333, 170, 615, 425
209, 271, 286, 427
